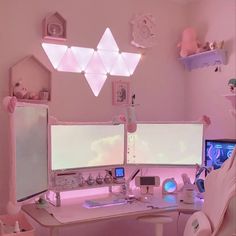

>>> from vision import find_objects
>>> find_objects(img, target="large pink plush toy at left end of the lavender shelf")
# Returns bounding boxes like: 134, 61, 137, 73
177, 27, 200, 57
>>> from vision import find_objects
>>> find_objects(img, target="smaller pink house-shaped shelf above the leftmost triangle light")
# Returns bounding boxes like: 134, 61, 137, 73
43, 12, 66, 40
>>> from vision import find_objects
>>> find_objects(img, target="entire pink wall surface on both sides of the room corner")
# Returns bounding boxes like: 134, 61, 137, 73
0, 0, 236, 235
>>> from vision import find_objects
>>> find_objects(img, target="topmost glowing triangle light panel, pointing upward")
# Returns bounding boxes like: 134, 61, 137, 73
97, 28, 119, 52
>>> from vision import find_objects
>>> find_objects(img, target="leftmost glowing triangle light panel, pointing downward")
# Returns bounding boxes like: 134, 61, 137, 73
42, 43, 68, 69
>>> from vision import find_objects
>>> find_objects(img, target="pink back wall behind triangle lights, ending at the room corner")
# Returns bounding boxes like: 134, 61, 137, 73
0, 0, 188, 211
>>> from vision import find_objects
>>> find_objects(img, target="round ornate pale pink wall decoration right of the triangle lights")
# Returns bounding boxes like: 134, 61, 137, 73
131, 14, 157, 48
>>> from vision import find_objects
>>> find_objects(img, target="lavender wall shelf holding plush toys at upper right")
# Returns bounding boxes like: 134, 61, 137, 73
179, 49, 226, 71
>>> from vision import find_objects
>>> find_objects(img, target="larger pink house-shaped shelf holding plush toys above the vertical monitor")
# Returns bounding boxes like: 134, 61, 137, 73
9, 55, 51, 103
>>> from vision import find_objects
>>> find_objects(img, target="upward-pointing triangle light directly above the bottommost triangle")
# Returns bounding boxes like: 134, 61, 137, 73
85, 51, 107, 74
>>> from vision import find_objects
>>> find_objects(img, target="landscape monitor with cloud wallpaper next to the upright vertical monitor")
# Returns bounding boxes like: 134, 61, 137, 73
50, 123, 125, 170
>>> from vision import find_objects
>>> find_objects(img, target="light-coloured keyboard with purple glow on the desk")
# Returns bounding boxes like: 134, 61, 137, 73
84, 198, 127, 208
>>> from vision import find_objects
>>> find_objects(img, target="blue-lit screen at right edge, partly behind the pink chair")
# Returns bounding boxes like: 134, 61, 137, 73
205, 139, 236, 169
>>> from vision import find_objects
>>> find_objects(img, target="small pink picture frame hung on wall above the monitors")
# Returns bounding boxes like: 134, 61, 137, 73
112, 80, 130, 106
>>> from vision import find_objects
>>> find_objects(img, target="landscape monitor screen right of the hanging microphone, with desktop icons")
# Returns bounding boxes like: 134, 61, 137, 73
127, 123, 203, 166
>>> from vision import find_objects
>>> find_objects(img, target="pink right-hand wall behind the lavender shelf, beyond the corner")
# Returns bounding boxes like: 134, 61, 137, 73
186, 0, 236, 138
